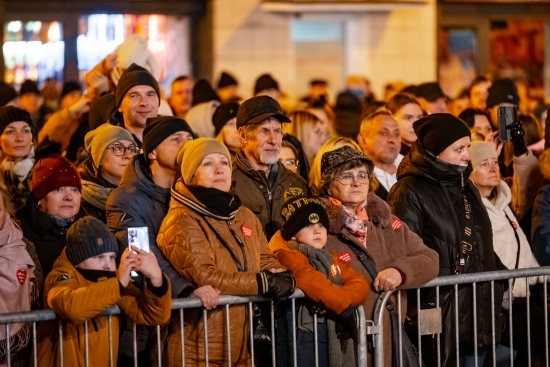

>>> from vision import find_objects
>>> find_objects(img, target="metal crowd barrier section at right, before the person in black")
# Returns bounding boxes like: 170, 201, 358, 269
371, 266, 550, 367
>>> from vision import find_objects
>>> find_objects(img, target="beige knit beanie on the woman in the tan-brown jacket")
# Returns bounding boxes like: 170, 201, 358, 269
177, 138, 231, 185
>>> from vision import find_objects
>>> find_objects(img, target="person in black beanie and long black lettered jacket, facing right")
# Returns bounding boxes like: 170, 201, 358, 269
388, 113, 504, 366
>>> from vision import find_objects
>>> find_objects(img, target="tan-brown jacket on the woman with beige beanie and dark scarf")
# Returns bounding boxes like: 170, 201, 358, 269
157, 180, 281, 366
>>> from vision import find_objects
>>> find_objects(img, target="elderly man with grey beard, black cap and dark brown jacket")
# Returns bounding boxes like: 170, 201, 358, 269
233, 96, 307, 240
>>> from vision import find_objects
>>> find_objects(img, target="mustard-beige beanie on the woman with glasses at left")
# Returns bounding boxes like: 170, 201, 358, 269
84, 122, 135, 168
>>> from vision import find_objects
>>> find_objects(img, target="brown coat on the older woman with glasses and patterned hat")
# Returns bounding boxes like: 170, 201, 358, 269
322, 192, 438, 366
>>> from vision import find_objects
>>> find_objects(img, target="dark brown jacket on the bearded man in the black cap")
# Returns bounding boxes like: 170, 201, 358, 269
233, 149, 308, 240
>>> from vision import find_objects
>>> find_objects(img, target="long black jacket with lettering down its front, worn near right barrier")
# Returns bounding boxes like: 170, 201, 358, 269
388, 142, 506, 366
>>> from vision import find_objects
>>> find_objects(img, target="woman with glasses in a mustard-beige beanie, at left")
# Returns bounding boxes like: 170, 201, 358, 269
78, 124, 139, 223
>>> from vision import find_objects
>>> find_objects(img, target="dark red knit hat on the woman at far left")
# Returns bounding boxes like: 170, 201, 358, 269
32, 154, 82, 201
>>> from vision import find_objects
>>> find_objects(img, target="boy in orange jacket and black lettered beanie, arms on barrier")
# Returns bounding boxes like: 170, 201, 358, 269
269, 188, 369, 366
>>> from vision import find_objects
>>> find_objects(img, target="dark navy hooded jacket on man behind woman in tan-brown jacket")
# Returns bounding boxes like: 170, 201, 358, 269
106, 154, 193, 298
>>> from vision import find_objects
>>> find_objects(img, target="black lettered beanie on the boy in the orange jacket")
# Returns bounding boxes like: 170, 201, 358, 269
281, 188, 330, 241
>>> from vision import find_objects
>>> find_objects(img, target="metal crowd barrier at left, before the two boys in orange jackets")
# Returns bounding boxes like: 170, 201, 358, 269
0, 289, 367, 367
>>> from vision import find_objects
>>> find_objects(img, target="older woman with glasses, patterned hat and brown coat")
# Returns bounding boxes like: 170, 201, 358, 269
314, 145, 439, 366
